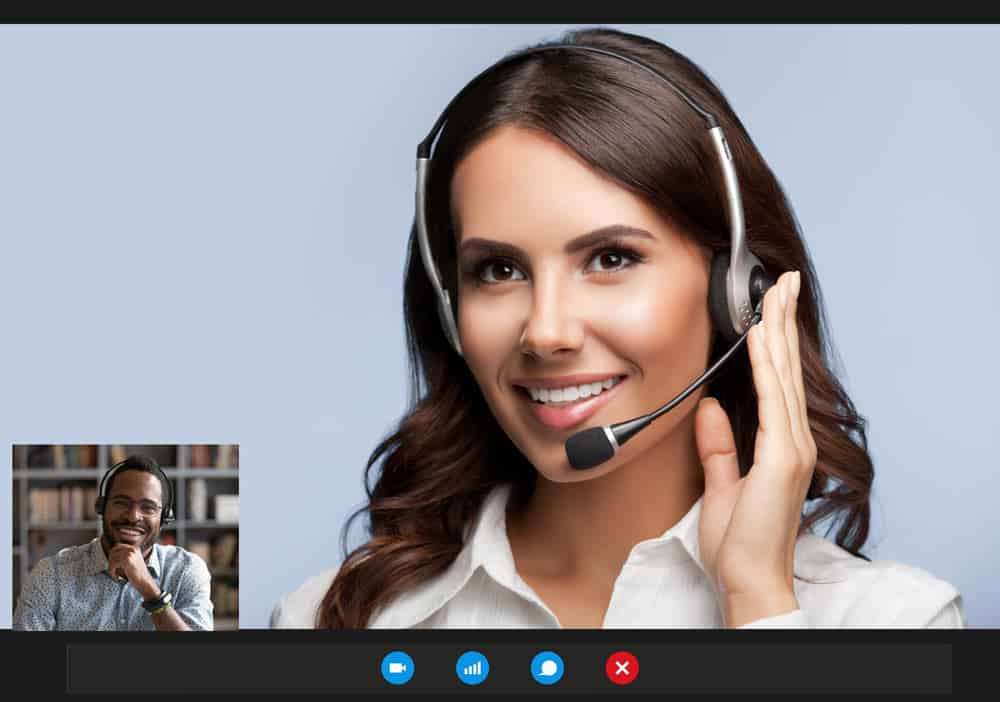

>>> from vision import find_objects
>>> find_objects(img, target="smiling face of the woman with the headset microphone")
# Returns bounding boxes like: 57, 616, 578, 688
452, 127, 712, 478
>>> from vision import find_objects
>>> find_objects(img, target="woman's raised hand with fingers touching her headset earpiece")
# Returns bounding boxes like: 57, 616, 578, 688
695, 272, 816, 627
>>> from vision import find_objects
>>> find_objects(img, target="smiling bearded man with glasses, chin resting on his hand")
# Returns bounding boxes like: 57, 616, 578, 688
13, 455, 212, 631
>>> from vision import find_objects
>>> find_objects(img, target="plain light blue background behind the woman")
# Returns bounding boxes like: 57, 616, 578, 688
0, 25, 1000, 627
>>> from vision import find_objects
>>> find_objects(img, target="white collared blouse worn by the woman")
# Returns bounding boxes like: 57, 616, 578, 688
271, 485, 965, 629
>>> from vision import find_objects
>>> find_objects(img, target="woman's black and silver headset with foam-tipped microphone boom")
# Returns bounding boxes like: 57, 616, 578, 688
414, 44, 774, 470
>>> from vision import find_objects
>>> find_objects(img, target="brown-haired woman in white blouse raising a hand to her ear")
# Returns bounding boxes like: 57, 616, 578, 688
272, 30, 964, 628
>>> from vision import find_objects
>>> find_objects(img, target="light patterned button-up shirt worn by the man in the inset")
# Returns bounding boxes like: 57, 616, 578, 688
13, 538, 212, 631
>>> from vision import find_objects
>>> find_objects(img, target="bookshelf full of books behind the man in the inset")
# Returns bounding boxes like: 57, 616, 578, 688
12, 444, 239, 630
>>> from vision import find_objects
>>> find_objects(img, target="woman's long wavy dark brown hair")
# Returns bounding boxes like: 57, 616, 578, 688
316, 29, 874, 629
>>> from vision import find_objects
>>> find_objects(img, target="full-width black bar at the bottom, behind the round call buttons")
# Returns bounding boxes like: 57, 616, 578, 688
0, 629, 1000, 700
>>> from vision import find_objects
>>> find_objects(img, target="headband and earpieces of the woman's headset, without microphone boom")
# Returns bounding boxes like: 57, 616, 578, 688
415, 44, 774, 356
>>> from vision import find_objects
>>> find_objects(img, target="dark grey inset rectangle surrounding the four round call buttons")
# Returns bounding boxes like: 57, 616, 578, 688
67, 636, 952, 698
